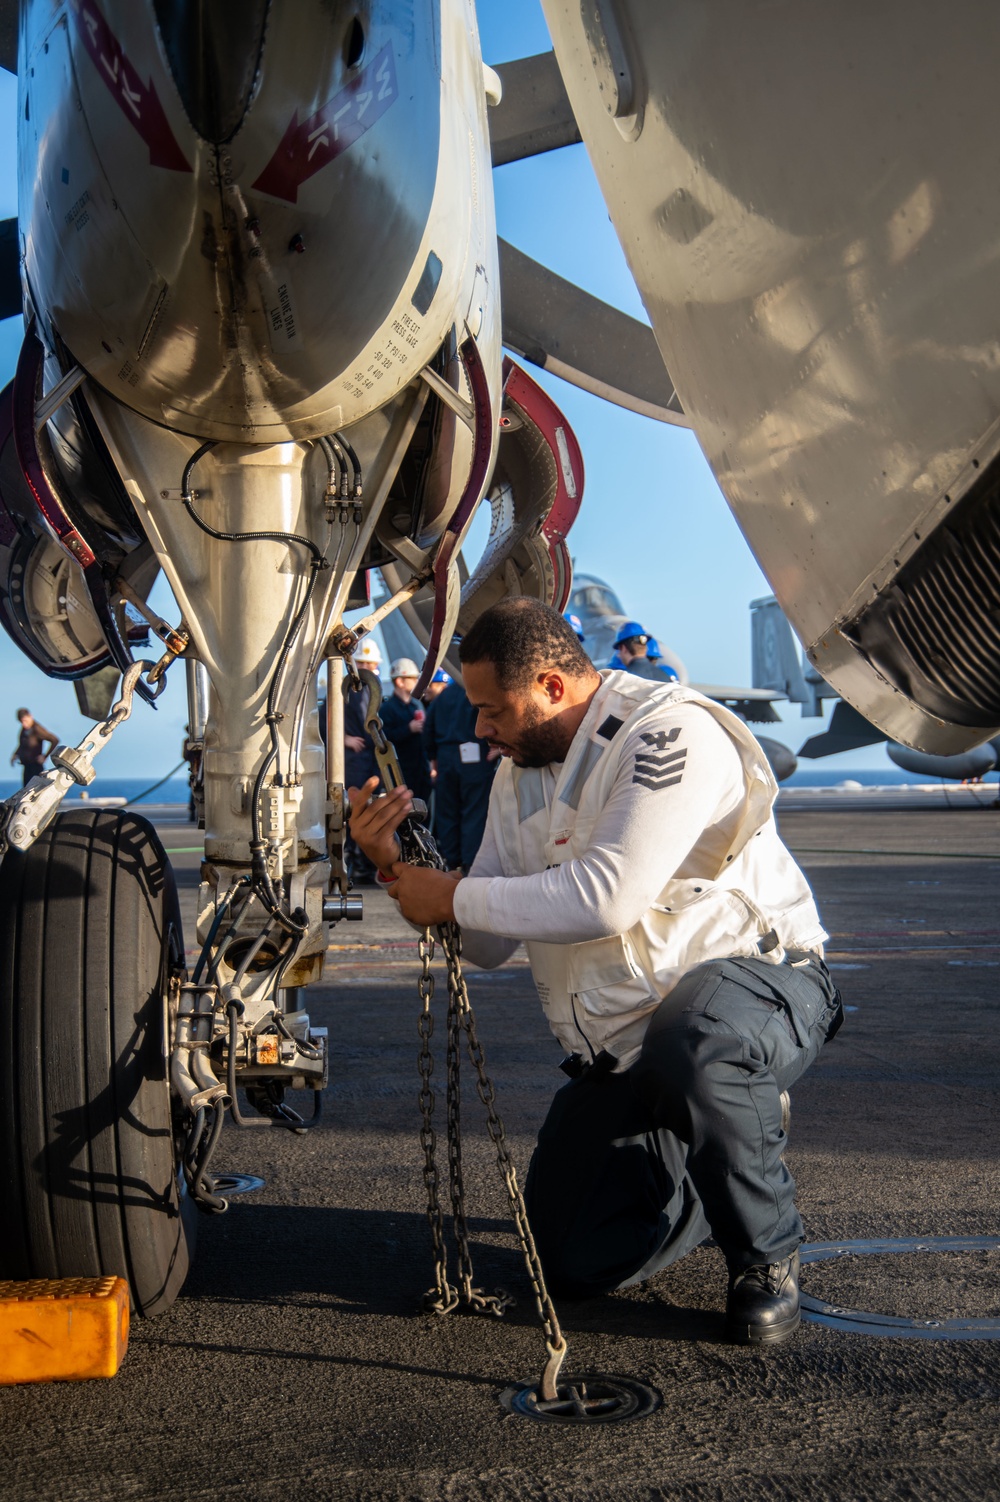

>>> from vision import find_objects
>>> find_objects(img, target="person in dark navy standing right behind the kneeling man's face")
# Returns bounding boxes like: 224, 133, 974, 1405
420, 669, 500, 871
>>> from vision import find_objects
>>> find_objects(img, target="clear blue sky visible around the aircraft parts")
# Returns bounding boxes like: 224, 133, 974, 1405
0, 0, 887, 780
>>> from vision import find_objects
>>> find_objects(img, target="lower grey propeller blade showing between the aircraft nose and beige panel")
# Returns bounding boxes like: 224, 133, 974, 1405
497, 240, 691, 428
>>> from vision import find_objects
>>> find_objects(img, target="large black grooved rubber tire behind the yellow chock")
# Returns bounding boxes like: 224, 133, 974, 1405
0, 810, 197, 1314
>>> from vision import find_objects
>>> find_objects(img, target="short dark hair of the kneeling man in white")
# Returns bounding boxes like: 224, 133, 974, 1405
458, 595, 595, 689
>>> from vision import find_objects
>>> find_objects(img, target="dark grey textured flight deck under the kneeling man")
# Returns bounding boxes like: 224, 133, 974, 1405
0, 787, 1000, 1502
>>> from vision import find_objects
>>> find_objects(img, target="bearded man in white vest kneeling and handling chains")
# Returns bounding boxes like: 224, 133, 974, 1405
350, 598, 842, 1344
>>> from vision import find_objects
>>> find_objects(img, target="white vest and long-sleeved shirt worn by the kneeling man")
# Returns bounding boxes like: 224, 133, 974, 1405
455, 671, 826, 1069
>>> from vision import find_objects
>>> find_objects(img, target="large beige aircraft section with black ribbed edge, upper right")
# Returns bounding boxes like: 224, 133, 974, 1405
542, 0, 1000, 753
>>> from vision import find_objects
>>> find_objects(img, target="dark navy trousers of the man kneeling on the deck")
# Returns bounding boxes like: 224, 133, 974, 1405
526, 954, 844, 1298
